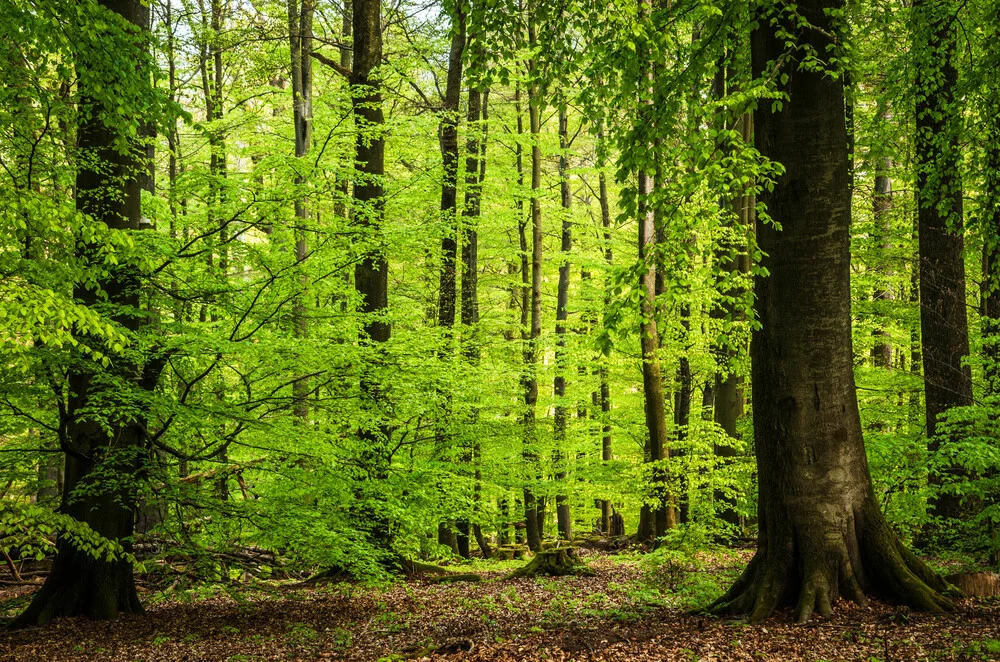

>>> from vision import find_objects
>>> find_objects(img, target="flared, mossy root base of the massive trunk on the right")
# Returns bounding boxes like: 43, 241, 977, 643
708, 504, 961, 623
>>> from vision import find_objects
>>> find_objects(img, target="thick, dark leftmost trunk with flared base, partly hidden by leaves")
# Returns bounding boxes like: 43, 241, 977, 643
12, 0, 162, 628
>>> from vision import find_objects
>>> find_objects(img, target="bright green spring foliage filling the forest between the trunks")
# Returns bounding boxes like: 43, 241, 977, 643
0, 0, 1000, 620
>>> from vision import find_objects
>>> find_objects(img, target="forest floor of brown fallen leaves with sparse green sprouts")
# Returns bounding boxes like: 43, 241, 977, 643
0, 553, 1000, 662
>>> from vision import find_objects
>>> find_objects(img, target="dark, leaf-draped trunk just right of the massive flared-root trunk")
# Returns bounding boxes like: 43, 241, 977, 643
913, 0, 972, 517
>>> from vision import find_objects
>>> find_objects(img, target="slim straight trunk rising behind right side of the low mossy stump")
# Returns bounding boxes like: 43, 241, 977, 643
552, 105, 573, 540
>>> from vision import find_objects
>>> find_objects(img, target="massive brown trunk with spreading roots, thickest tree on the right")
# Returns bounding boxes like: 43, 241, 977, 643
713, 0, 952, 622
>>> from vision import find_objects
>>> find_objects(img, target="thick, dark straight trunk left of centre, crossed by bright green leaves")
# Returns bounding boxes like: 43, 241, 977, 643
350, 0, 392, 547
